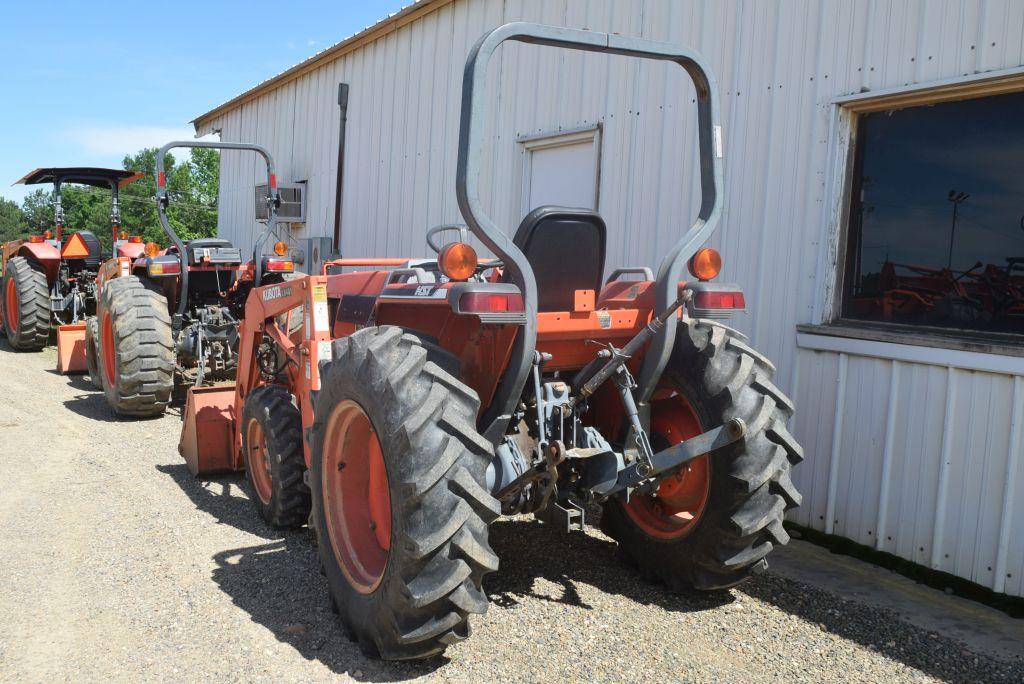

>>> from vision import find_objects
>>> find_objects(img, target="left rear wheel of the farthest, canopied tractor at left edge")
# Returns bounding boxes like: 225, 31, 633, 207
2, 257, 51, 351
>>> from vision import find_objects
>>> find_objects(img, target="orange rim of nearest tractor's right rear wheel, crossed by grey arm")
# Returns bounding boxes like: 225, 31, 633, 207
625, 389, 711, 540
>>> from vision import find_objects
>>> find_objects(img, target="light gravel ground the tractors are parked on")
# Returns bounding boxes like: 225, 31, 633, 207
0, 341, 1024, 682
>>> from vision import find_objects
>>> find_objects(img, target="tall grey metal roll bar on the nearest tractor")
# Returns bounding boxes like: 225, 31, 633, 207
456, 23, 723, 440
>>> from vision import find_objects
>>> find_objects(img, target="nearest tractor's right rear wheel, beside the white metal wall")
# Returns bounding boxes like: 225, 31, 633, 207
601, 320, 803, 590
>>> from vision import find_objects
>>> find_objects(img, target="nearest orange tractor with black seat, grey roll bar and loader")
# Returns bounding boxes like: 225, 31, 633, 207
179, 24, 802, 658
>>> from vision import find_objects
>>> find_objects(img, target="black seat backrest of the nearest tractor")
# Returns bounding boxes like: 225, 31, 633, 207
513, 207, 607, 311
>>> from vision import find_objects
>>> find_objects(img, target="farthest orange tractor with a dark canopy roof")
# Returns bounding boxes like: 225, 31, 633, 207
0, 167, 143, 373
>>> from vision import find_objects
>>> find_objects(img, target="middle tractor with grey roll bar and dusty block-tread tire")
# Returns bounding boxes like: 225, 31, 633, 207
87, 141, 295, 417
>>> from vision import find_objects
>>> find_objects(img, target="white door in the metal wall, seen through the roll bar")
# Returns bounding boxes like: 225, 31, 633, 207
522, 129, 600, 216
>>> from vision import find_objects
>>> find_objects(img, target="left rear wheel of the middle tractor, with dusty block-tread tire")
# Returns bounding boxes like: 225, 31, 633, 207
98, 275, 174, 418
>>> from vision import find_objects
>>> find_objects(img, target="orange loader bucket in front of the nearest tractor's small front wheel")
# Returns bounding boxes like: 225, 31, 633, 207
178, 385, 237, 475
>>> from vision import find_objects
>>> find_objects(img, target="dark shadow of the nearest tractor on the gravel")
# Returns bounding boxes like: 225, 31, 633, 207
193, 497, 733, 682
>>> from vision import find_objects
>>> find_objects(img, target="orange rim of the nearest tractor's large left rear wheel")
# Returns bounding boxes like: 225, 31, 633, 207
322, 400, 391, 594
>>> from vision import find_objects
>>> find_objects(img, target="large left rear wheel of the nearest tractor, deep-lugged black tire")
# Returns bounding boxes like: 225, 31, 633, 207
309, 326, 500, 659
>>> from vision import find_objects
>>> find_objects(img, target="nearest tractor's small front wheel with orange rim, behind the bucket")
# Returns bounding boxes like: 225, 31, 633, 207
242, 385, 309, 529
